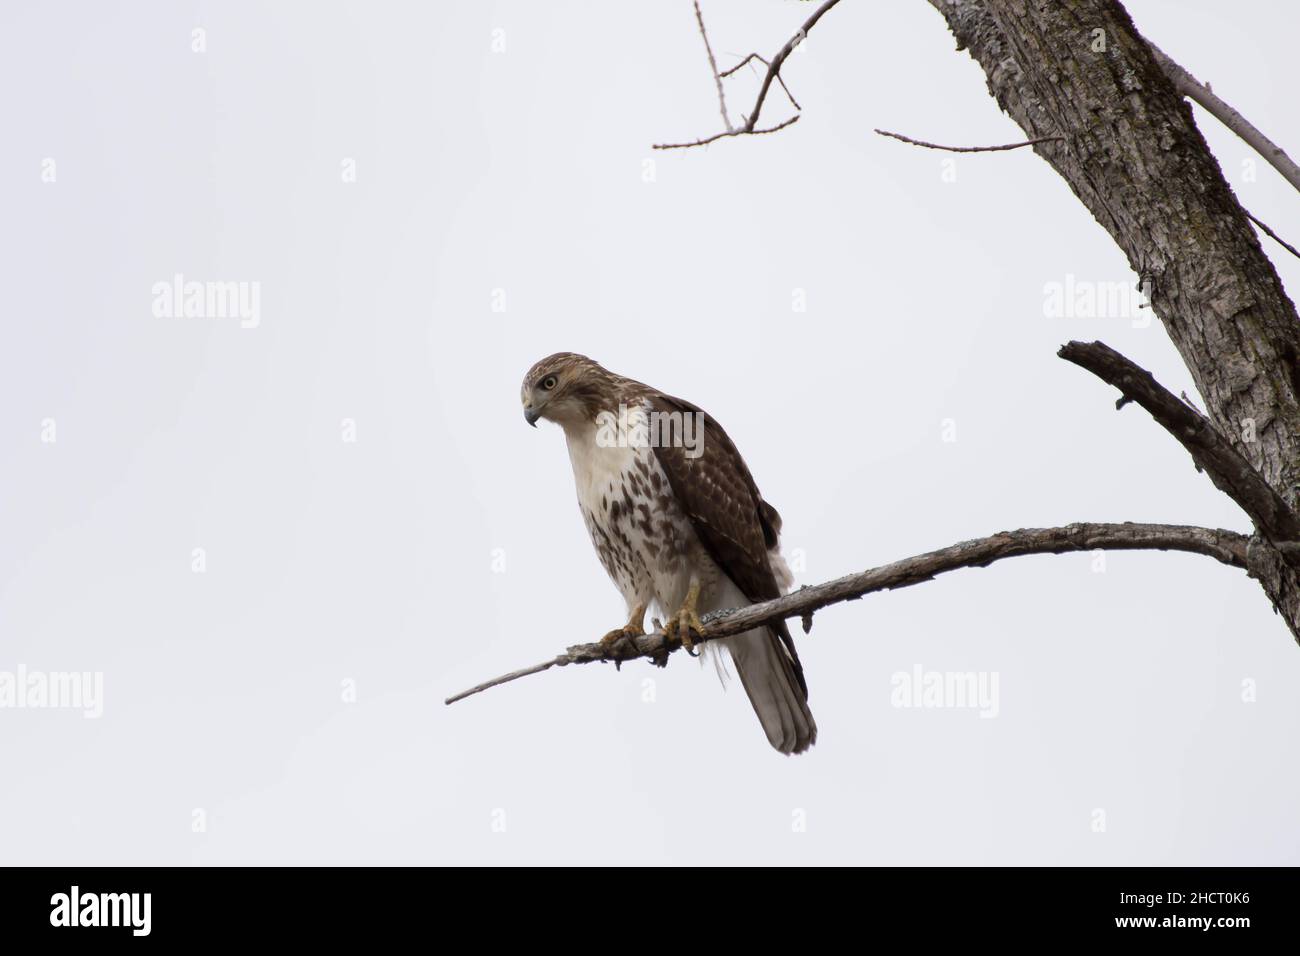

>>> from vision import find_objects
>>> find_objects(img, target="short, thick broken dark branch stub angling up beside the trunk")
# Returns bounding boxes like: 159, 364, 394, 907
1057, 342, 1300, 544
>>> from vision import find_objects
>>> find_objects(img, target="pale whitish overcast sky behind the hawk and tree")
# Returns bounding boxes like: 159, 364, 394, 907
0, 0, 1300, 864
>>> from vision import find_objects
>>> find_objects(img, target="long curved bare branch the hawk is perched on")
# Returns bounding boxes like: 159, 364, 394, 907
446, 522, 1249, 704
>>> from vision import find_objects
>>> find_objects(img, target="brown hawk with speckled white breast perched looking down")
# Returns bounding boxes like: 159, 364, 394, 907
521, 352, 816, 753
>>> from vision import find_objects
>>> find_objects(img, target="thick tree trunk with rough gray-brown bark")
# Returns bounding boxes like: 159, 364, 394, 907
928, 0, 1300, 640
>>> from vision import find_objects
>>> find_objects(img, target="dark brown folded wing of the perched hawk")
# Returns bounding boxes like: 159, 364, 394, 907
650, 394, 809, 698
